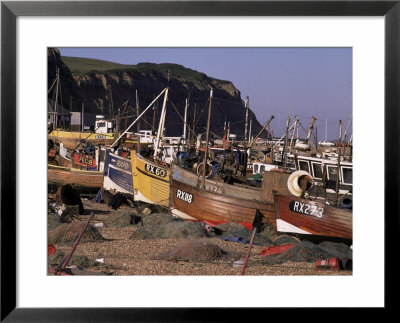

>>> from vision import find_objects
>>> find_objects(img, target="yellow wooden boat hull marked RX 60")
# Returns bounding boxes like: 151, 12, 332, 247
131, 150, 171, 206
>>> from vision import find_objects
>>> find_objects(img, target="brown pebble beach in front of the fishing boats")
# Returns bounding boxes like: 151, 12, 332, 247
48, 198, 352, 276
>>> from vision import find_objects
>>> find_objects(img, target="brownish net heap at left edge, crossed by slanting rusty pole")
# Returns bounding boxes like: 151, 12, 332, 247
48, 222, 105, 244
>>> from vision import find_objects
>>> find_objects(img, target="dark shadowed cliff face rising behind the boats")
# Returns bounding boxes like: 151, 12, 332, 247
48, 49, 261, 137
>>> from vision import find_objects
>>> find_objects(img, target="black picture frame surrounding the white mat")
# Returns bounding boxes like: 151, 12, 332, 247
0, 0, 400, 322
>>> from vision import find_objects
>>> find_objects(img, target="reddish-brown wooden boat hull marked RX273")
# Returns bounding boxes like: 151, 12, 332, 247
275, 194, 353, 239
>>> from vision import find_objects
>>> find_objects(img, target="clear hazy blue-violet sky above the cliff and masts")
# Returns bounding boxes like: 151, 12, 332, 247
59, 47, 353, 141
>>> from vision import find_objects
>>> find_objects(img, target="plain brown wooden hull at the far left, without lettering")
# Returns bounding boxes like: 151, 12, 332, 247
47, 165, 104, 188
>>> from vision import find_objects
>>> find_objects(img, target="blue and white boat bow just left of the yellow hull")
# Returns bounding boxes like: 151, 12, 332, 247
103, 150, 133, 195
